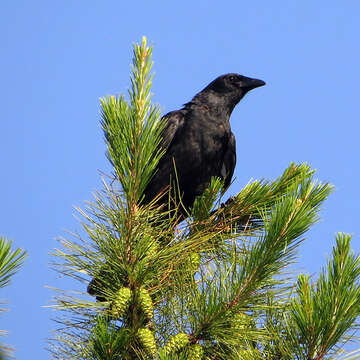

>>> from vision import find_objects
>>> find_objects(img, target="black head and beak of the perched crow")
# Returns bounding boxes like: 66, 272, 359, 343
195, 73, 265, 112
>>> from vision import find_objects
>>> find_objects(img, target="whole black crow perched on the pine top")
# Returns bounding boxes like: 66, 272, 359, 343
142, 74, 265, 217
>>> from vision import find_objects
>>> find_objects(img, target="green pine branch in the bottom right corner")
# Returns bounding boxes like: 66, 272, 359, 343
291, 234, 360, 360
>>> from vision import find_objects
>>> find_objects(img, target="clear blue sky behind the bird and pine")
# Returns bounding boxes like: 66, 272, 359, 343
0, 0, 360, 360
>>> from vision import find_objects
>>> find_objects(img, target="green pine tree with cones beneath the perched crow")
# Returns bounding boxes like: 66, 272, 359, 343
51, 38, 360, 360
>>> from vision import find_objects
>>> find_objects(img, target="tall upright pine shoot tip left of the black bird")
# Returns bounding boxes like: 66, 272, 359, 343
101, 37, 163, 207
